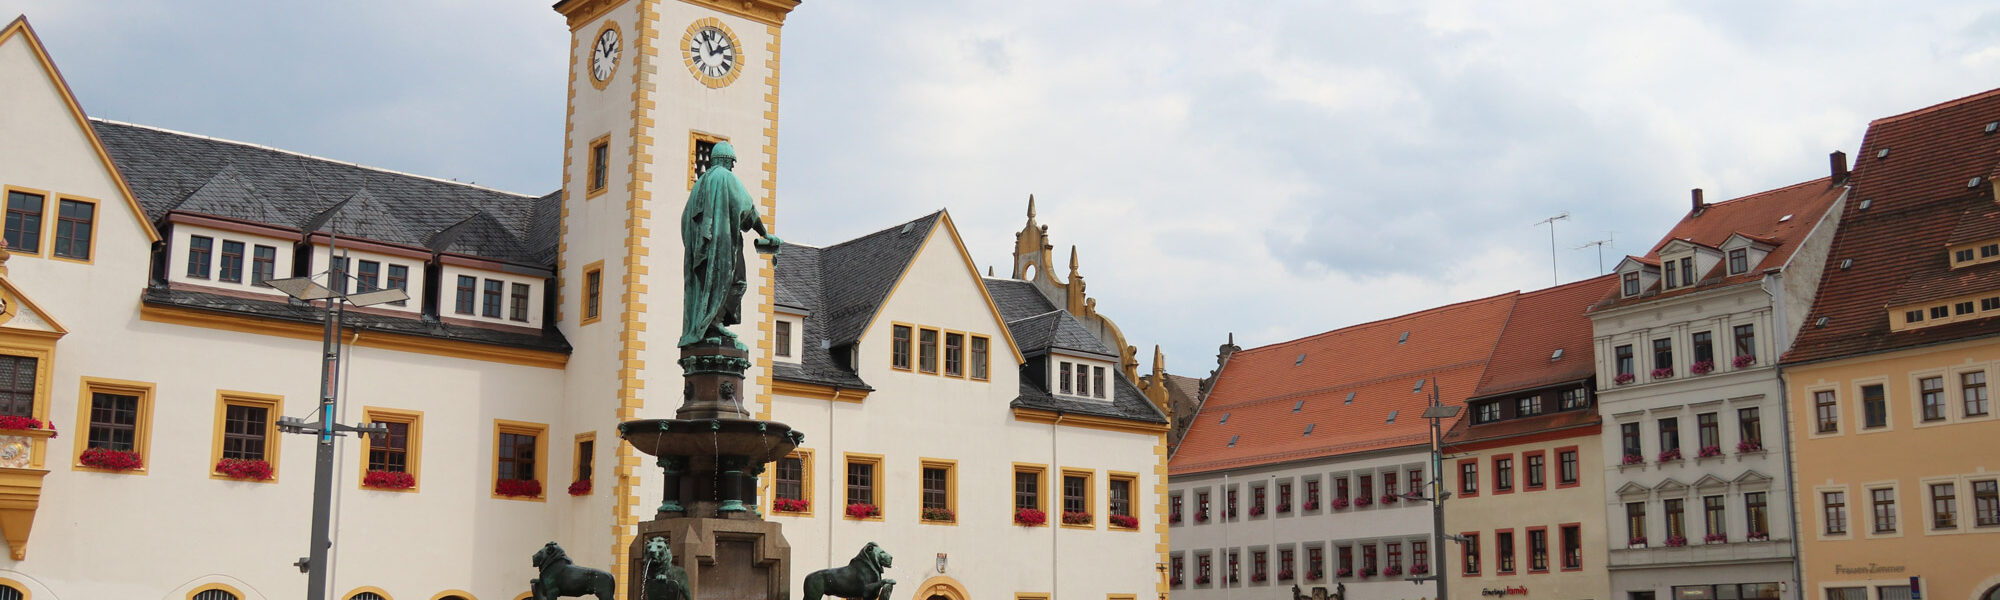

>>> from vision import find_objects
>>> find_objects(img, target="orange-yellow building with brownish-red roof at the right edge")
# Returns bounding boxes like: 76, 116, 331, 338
1784, 90, 2000, 600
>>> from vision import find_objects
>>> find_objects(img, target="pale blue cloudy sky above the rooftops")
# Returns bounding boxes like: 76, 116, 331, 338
15, 0, 2000, 374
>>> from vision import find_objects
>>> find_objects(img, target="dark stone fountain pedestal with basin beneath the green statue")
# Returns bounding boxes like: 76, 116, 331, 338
618, 344, 804, 600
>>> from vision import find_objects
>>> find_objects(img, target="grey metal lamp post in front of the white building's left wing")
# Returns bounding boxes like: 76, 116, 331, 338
266, 200, 410, 600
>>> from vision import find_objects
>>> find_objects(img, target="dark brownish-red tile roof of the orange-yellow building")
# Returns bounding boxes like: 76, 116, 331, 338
1784, 90, 2000, 364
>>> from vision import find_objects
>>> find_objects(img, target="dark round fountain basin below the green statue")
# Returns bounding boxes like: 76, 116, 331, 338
618, 418, 802, 466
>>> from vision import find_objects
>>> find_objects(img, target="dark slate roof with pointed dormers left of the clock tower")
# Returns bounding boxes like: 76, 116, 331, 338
90, 120, 560, 268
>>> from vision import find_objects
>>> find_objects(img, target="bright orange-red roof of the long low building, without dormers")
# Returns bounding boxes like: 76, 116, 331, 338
1170, 292, 1520, 474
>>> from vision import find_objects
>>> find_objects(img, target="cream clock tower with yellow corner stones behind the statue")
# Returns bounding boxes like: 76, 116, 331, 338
548, 0, 798, 588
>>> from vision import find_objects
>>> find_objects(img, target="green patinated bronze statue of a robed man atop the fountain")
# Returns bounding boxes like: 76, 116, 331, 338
680, 142, 784, 350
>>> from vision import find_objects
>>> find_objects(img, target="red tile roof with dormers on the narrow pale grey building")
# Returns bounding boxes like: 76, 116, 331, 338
1592, 178, 1852, 310
